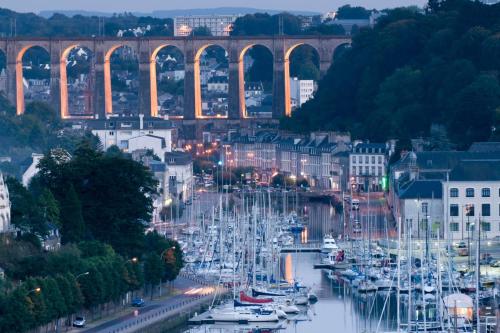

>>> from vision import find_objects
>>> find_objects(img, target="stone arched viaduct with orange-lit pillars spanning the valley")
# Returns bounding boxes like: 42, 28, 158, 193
0, 36, 351, 120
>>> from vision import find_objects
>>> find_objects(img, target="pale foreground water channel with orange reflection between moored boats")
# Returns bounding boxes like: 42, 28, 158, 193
176, 253, 396, 333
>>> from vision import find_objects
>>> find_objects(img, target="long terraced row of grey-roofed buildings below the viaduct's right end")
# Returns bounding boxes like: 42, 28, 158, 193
226, 131, 350, 191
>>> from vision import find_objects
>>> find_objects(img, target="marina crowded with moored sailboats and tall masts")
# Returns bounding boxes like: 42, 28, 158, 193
157, 191, 499, 333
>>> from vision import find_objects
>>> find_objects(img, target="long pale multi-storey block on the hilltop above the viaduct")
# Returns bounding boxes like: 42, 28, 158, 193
174, 15, 240, 36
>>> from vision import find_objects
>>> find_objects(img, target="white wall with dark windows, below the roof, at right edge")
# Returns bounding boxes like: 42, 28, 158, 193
443, 181, 500, 240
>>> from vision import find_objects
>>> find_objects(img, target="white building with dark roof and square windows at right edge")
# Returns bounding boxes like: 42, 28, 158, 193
443, 159, 500, 241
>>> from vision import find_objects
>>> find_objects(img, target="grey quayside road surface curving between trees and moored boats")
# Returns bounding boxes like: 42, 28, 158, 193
67, 276, 215, 333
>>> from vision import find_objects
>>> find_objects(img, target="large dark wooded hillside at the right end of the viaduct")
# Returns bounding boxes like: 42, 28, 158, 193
282, 0, 500, 148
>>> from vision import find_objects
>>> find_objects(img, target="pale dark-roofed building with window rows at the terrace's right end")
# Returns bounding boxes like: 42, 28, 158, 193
349, 143, 390, 191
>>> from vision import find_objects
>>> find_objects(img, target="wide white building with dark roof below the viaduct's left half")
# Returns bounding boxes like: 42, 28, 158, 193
87, 115, 174, 160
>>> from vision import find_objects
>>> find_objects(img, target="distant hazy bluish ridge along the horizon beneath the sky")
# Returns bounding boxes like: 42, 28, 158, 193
39, 7, 320, 18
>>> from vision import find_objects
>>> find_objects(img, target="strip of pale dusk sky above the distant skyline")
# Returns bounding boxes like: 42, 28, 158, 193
0, 0, 427, 12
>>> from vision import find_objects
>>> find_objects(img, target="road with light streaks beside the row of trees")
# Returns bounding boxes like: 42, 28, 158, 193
70, 276, 215, 333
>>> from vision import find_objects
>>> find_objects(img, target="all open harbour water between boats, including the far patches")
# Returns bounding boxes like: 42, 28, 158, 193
171, 203, 396, 333
